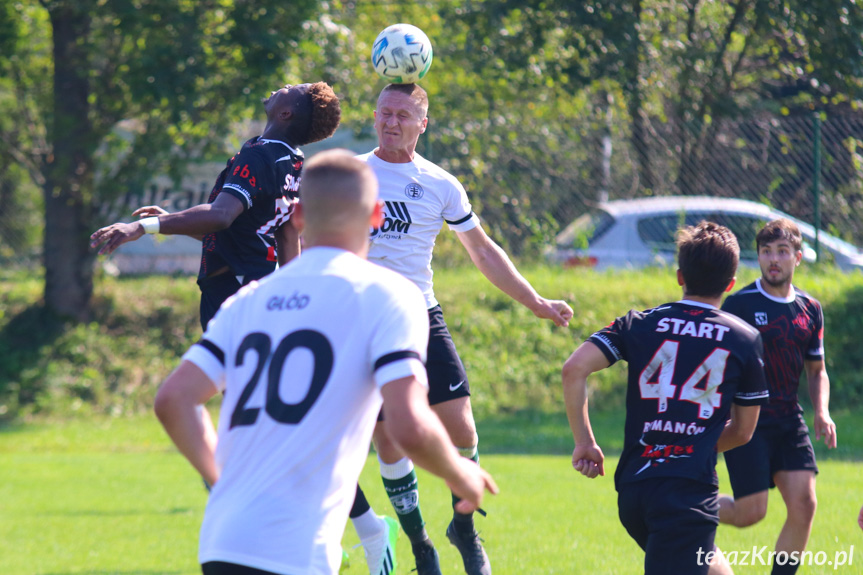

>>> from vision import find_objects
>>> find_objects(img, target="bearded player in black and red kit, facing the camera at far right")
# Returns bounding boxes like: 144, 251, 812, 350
719, 219, 836, 575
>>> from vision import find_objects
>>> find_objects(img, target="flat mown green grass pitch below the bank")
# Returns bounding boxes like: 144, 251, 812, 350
0, 414, 863, 575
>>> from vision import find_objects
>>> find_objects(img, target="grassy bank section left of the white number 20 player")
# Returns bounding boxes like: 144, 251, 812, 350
0, 274, 200, 418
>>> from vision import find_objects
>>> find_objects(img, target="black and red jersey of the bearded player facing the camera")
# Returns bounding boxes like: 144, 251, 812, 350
722, 279, 824, 424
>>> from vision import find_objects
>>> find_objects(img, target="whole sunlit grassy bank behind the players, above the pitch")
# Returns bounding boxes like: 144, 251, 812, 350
0, 266, 863, 424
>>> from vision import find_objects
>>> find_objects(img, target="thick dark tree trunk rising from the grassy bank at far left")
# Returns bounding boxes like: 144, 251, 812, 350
44, 0, 94, 320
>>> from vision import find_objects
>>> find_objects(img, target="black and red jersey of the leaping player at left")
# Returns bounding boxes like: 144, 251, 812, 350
198, 136, 303, 283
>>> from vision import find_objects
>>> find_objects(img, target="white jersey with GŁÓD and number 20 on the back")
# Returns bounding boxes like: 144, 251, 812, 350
188, 247, 429, 575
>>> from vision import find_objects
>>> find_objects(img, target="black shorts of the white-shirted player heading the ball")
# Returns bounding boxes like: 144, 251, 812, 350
378, 305, 470, 421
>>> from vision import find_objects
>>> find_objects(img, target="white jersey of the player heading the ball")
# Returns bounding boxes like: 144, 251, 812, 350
357, 151, 479, 308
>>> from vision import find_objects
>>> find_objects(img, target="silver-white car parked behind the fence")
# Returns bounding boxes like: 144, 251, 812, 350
547, 196, 863, 270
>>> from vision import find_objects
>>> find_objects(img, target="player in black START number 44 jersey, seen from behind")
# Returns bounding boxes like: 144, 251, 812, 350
563, 222, 768, 575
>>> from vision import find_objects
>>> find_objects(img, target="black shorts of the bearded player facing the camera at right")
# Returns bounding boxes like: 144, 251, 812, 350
724, 414, 818, 498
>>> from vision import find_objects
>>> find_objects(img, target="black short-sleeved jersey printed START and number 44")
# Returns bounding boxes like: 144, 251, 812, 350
588, 300, 767, 486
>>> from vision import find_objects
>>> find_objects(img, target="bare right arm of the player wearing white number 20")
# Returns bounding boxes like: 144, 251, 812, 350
381, 377, 498, 513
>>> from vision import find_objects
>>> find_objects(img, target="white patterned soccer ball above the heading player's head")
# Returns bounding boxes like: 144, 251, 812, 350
372, 24, 432, 84
